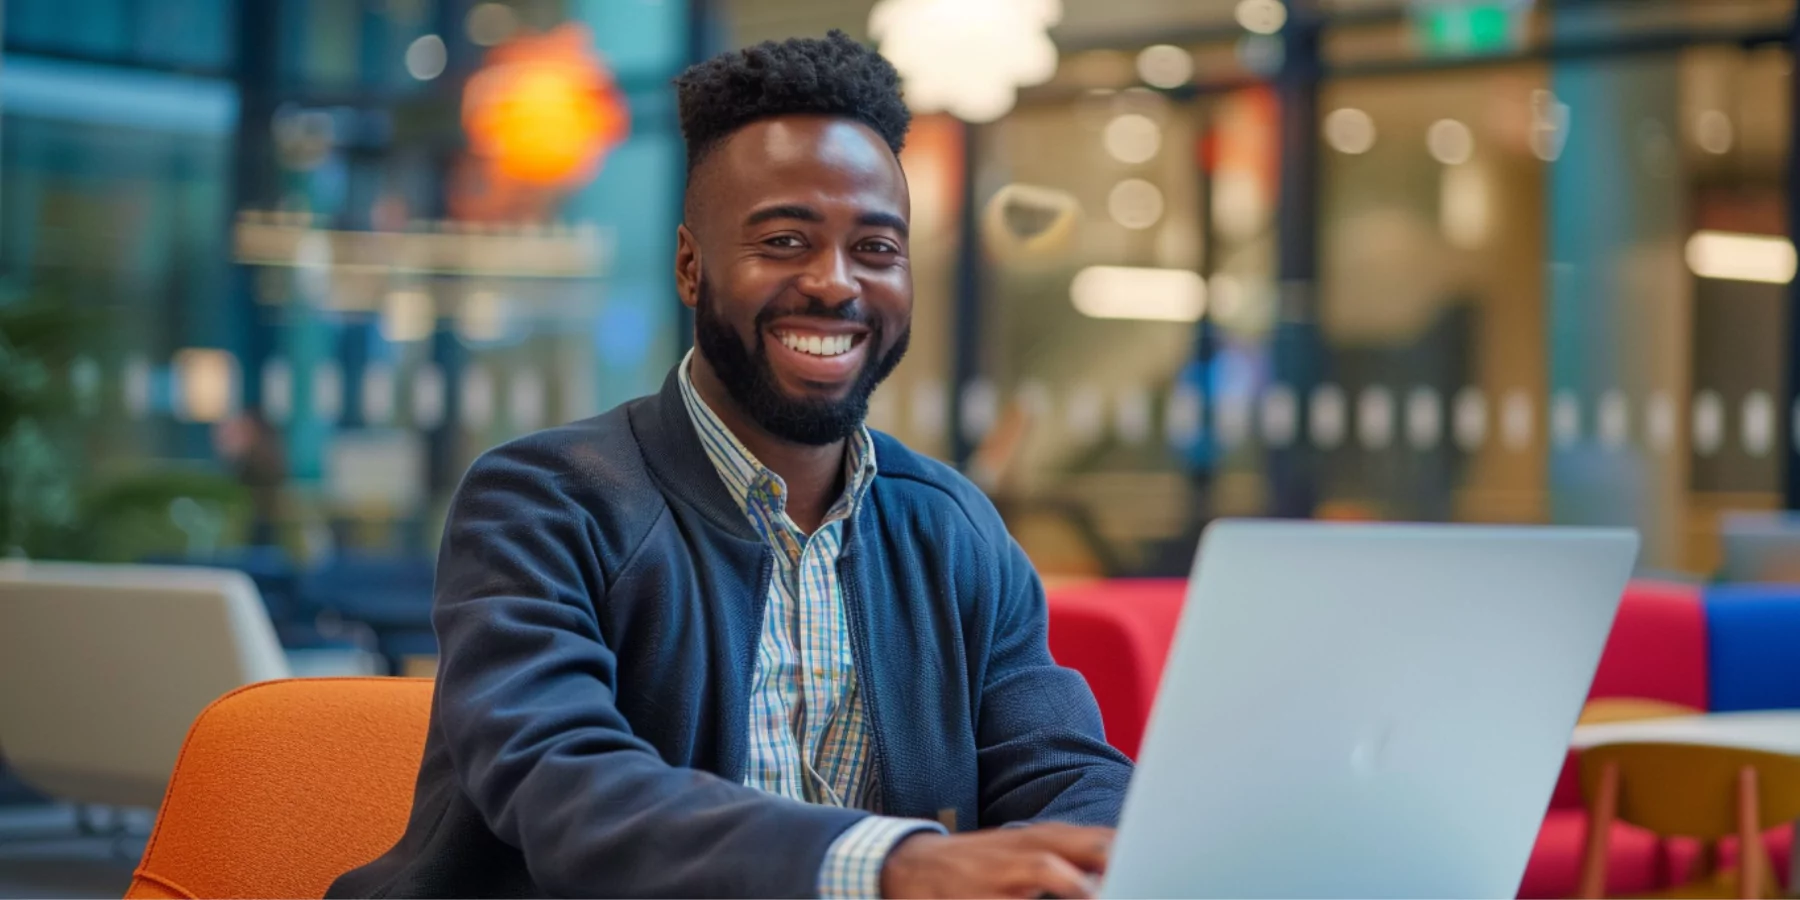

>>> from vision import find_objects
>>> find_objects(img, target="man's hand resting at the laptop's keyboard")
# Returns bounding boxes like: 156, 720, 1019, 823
882, 823, 1112, 900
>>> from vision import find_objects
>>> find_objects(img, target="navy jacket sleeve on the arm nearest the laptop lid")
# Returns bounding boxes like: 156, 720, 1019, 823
976, 515, 1132, 826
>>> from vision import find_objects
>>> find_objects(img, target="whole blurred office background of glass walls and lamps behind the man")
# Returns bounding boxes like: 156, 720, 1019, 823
0, 0, 1800, 892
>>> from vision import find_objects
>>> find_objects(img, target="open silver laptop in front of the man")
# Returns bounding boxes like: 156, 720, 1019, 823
1102, 522, 1638, 898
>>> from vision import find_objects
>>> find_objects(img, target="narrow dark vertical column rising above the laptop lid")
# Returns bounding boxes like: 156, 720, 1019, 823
1267, 0, 1325, 518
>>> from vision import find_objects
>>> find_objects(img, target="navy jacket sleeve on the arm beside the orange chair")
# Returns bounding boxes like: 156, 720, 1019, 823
432, 448, 866, 896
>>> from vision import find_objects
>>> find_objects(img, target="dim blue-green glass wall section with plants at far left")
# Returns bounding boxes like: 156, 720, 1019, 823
0, 0, 241, 554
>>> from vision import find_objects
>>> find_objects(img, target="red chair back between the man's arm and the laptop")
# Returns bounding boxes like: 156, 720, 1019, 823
1048, 578, 1188, 758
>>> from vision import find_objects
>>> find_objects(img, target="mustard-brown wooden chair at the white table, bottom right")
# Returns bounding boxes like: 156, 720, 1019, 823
1579, 743, 1800, 898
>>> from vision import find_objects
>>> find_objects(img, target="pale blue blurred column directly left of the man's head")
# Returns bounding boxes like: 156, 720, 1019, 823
567, 0, 695, 409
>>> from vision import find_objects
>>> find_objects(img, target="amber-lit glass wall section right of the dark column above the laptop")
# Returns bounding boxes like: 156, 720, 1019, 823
1321, 35, 1791, 571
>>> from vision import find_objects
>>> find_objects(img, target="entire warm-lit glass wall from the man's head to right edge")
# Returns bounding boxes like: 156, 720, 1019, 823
712, 0, 1793, 574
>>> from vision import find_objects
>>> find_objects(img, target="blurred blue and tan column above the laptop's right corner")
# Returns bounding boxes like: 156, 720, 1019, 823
1535, 7, 1692, 569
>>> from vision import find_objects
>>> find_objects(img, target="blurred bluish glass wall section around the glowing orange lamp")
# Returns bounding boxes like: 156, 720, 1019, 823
238, 2, 686, 553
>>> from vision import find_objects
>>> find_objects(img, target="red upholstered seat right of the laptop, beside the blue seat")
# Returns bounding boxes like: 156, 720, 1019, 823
1519, 581, 1706, 898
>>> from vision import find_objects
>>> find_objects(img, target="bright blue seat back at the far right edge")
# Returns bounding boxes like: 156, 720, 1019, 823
1705, 585, 1800, 713
